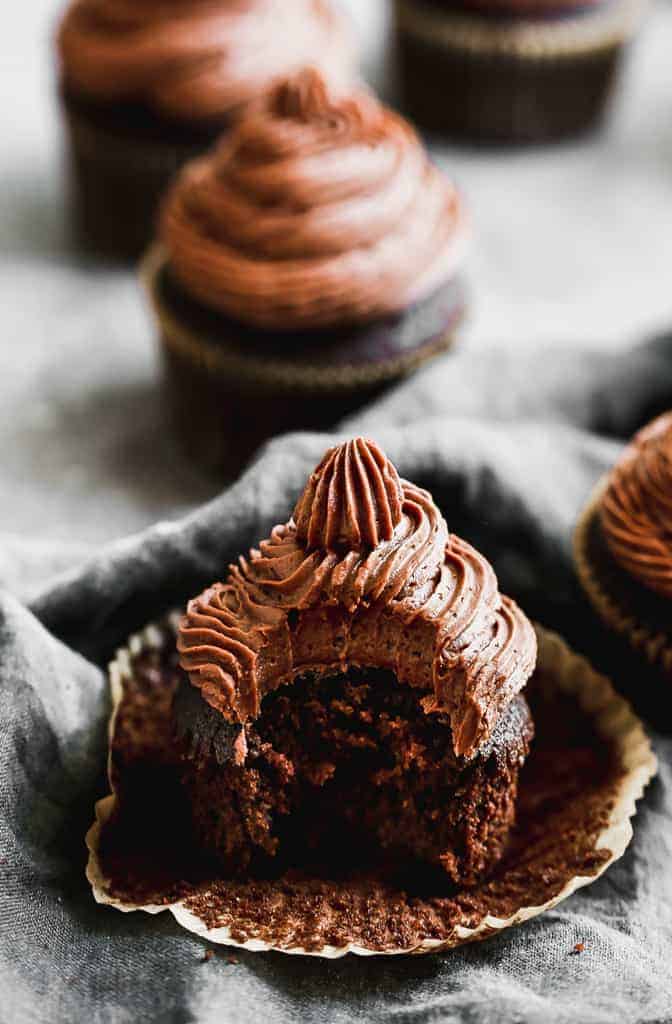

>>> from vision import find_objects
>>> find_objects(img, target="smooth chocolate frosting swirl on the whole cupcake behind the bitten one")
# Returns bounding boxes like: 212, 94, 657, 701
161, 69, 465, 331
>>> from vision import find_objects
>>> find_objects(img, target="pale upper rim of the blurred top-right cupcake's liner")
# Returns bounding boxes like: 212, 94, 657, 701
395, 0, 648, 60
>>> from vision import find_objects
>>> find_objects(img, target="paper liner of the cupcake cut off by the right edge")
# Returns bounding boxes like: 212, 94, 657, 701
574, 476, 672, 680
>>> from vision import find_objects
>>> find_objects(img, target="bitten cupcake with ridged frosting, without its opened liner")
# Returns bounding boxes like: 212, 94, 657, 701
175, 439, 537, 885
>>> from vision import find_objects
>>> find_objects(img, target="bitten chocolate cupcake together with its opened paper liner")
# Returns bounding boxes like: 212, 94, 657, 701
87, 438, 656, 956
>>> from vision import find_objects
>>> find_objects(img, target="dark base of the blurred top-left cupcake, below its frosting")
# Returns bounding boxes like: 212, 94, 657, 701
61, 93, 224, 261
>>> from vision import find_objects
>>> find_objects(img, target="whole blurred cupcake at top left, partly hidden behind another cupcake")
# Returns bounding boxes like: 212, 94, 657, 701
58, 0, 352, 258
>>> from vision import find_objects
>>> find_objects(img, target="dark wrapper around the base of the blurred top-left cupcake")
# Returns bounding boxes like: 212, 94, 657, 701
64, 100, 210, 259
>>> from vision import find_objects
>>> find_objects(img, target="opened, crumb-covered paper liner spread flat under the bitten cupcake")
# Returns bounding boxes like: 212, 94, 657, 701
86, 620, 657, 957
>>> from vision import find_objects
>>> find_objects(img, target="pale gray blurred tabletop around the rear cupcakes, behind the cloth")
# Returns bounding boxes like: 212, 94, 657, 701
0, 0, 672, 544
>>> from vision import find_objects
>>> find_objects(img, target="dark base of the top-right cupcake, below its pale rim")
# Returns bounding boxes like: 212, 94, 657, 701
397, 15, 624, 145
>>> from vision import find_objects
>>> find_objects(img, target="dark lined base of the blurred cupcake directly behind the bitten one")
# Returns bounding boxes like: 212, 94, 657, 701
150, 256, 465, 477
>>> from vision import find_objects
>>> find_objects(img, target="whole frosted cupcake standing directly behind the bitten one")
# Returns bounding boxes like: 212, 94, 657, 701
145, 70, 466, 473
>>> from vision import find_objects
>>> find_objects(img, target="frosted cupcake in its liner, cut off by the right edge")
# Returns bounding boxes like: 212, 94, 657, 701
575, 413, 672, 682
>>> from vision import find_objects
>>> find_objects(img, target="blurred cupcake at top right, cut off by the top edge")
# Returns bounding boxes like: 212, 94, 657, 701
395, 0, 645, 143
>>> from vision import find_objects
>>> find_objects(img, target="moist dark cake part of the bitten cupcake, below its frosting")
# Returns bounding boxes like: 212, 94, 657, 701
174, 670, 532, 885
